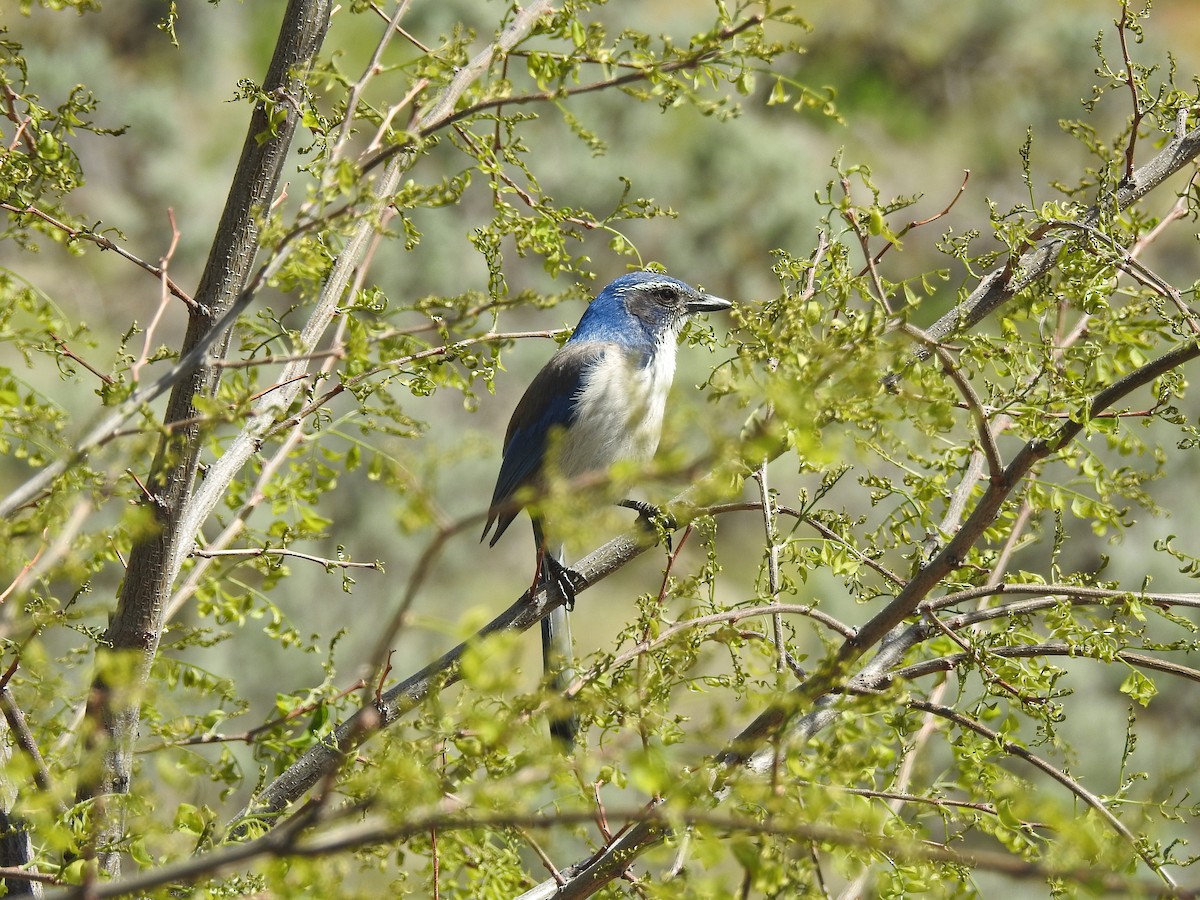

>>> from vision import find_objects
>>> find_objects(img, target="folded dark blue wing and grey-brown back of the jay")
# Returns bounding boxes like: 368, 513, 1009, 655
482, 341, 608, 545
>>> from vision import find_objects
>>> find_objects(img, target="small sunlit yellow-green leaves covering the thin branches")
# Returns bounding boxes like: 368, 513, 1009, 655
0, 2, 1200, 896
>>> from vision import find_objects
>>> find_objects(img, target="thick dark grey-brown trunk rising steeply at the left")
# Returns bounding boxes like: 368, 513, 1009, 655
78, 0, 331, 875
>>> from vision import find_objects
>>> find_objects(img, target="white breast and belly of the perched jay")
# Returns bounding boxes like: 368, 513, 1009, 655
558, 335, 676, 478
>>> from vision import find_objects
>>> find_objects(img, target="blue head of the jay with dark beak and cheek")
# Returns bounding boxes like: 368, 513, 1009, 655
571, 272, 733, 346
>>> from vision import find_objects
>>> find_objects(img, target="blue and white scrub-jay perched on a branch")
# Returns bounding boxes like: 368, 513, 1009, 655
480, 272, 732, 745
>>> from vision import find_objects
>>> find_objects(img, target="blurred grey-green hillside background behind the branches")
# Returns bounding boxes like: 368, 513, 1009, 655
0, 0, 1200, 864
